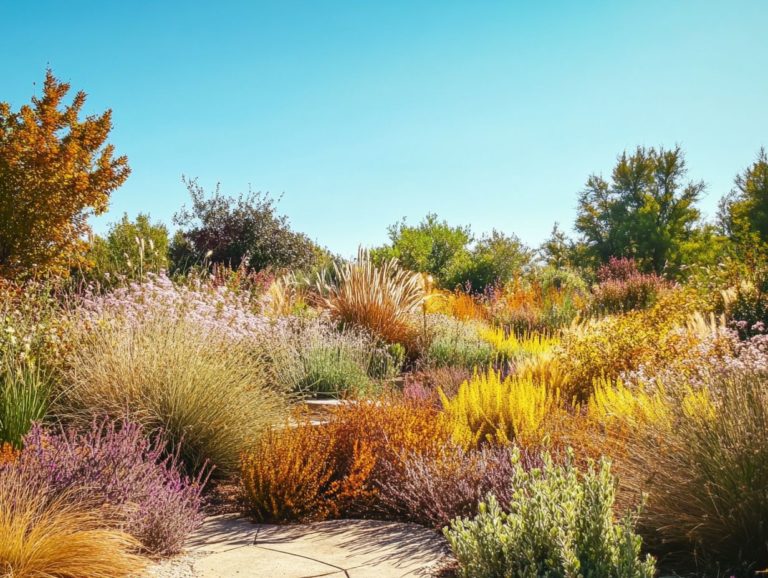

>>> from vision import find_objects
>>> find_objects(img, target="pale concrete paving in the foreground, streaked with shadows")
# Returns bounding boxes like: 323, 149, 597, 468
188, 515, 447, 578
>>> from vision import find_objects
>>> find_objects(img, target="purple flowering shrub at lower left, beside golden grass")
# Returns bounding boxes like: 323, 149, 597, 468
9, 420, 207, 556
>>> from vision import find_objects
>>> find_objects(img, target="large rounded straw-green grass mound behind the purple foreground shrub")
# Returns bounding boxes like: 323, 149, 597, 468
55, 311, 286, 474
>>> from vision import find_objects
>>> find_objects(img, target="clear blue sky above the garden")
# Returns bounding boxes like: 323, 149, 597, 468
0, 0, 768, 255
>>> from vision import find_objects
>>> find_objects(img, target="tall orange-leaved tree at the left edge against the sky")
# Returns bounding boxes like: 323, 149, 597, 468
0, 70, 130, 277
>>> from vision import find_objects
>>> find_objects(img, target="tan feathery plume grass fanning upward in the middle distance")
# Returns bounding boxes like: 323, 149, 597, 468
318, 248, 426, 350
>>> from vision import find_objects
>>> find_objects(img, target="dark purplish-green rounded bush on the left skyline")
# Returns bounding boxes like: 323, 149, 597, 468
171, 180, 324, 271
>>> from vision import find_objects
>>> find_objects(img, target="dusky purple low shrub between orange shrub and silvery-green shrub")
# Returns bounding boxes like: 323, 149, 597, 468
378, 443, 538, 528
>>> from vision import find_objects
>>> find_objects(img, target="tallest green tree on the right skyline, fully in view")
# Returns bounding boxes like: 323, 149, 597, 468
576, 147, 705, 275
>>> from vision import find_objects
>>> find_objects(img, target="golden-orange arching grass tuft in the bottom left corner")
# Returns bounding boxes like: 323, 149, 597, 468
0, 468, 147, 578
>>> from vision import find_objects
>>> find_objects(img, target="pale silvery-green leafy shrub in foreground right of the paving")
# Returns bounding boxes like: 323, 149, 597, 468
445, 454, 655, 578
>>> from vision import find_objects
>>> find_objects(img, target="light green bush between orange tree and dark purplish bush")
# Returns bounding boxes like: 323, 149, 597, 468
88, 213, 169, 282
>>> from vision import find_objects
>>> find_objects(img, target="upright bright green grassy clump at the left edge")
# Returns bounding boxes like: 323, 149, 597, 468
0, 355, 51, 448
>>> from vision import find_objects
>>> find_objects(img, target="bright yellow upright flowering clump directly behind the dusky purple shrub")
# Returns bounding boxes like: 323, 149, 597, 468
440, 369, 560, 445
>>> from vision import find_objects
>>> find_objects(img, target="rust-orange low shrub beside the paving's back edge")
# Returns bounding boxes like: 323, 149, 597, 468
241, 399, 450, 521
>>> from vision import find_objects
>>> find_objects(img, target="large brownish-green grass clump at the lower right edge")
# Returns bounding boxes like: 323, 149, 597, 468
616, 373, 768, 576
